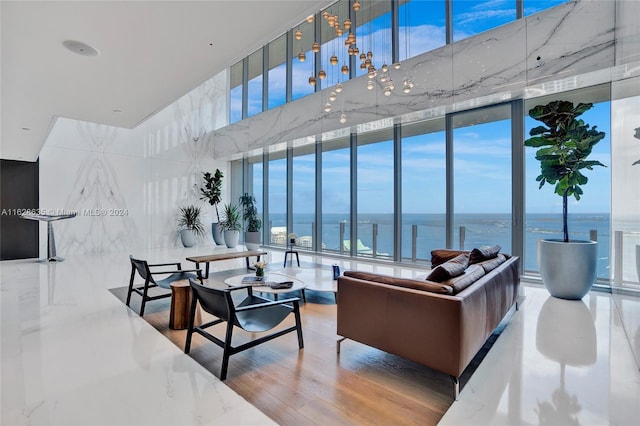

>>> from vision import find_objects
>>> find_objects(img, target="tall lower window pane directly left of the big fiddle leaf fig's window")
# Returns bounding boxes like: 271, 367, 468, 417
452, 105, 513, 253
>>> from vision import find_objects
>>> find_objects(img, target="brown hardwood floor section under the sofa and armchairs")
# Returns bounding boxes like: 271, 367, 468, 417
132, 270, 453, 425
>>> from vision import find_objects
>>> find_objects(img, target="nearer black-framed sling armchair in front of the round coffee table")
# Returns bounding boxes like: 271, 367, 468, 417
184, 279, 304, 380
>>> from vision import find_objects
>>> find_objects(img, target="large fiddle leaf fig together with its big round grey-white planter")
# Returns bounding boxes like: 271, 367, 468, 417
524, 101, 605, 299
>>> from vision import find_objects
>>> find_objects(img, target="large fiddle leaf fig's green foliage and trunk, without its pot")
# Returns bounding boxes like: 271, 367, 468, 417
524, 101, 606, 242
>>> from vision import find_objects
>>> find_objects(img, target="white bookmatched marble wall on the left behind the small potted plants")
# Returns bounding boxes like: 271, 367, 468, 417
40, 72, 229, 257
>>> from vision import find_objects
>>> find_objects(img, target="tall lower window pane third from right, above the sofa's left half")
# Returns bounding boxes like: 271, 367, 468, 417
401, 118, 447, 261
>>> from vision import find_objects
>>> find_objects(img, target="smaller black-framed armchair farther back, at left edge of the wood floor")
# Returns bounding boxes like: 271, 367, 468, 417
127, 256, 202, 316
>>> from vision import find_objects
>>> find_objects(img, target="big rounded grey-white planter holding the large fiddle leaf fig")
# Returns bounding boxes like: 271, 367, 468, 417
538, 240, 598, 300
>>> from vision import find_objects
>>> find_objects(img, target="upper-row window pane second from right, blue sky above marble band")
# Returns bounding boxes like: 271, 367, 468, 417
452, 0, 516, 41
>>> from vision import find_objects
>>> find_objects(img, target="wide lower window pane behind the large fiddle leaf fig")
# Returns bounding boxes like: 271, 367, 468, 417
524, 85, 611, 279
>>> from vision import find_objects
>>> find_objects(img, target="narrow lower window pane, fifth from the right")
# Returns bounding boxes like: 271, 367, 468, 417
320, 135, 351, 254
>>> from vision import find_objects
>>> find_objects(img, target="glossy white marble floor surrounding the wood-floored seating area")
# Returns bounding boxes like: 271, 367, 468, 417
0, 247, 640, 425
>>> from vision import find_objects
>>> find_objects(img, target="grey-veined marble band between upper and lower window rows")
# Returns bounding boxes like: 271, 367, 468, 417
214, 0, 618, 158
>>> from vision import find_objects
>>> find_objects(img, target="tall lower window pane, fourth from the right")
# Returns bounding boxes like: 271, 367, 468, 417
356, 128, 395, 259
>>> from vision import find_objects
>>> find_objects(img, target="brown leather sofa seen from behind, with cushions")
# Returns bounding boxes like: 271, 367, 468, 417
337, 250, 520, 399
